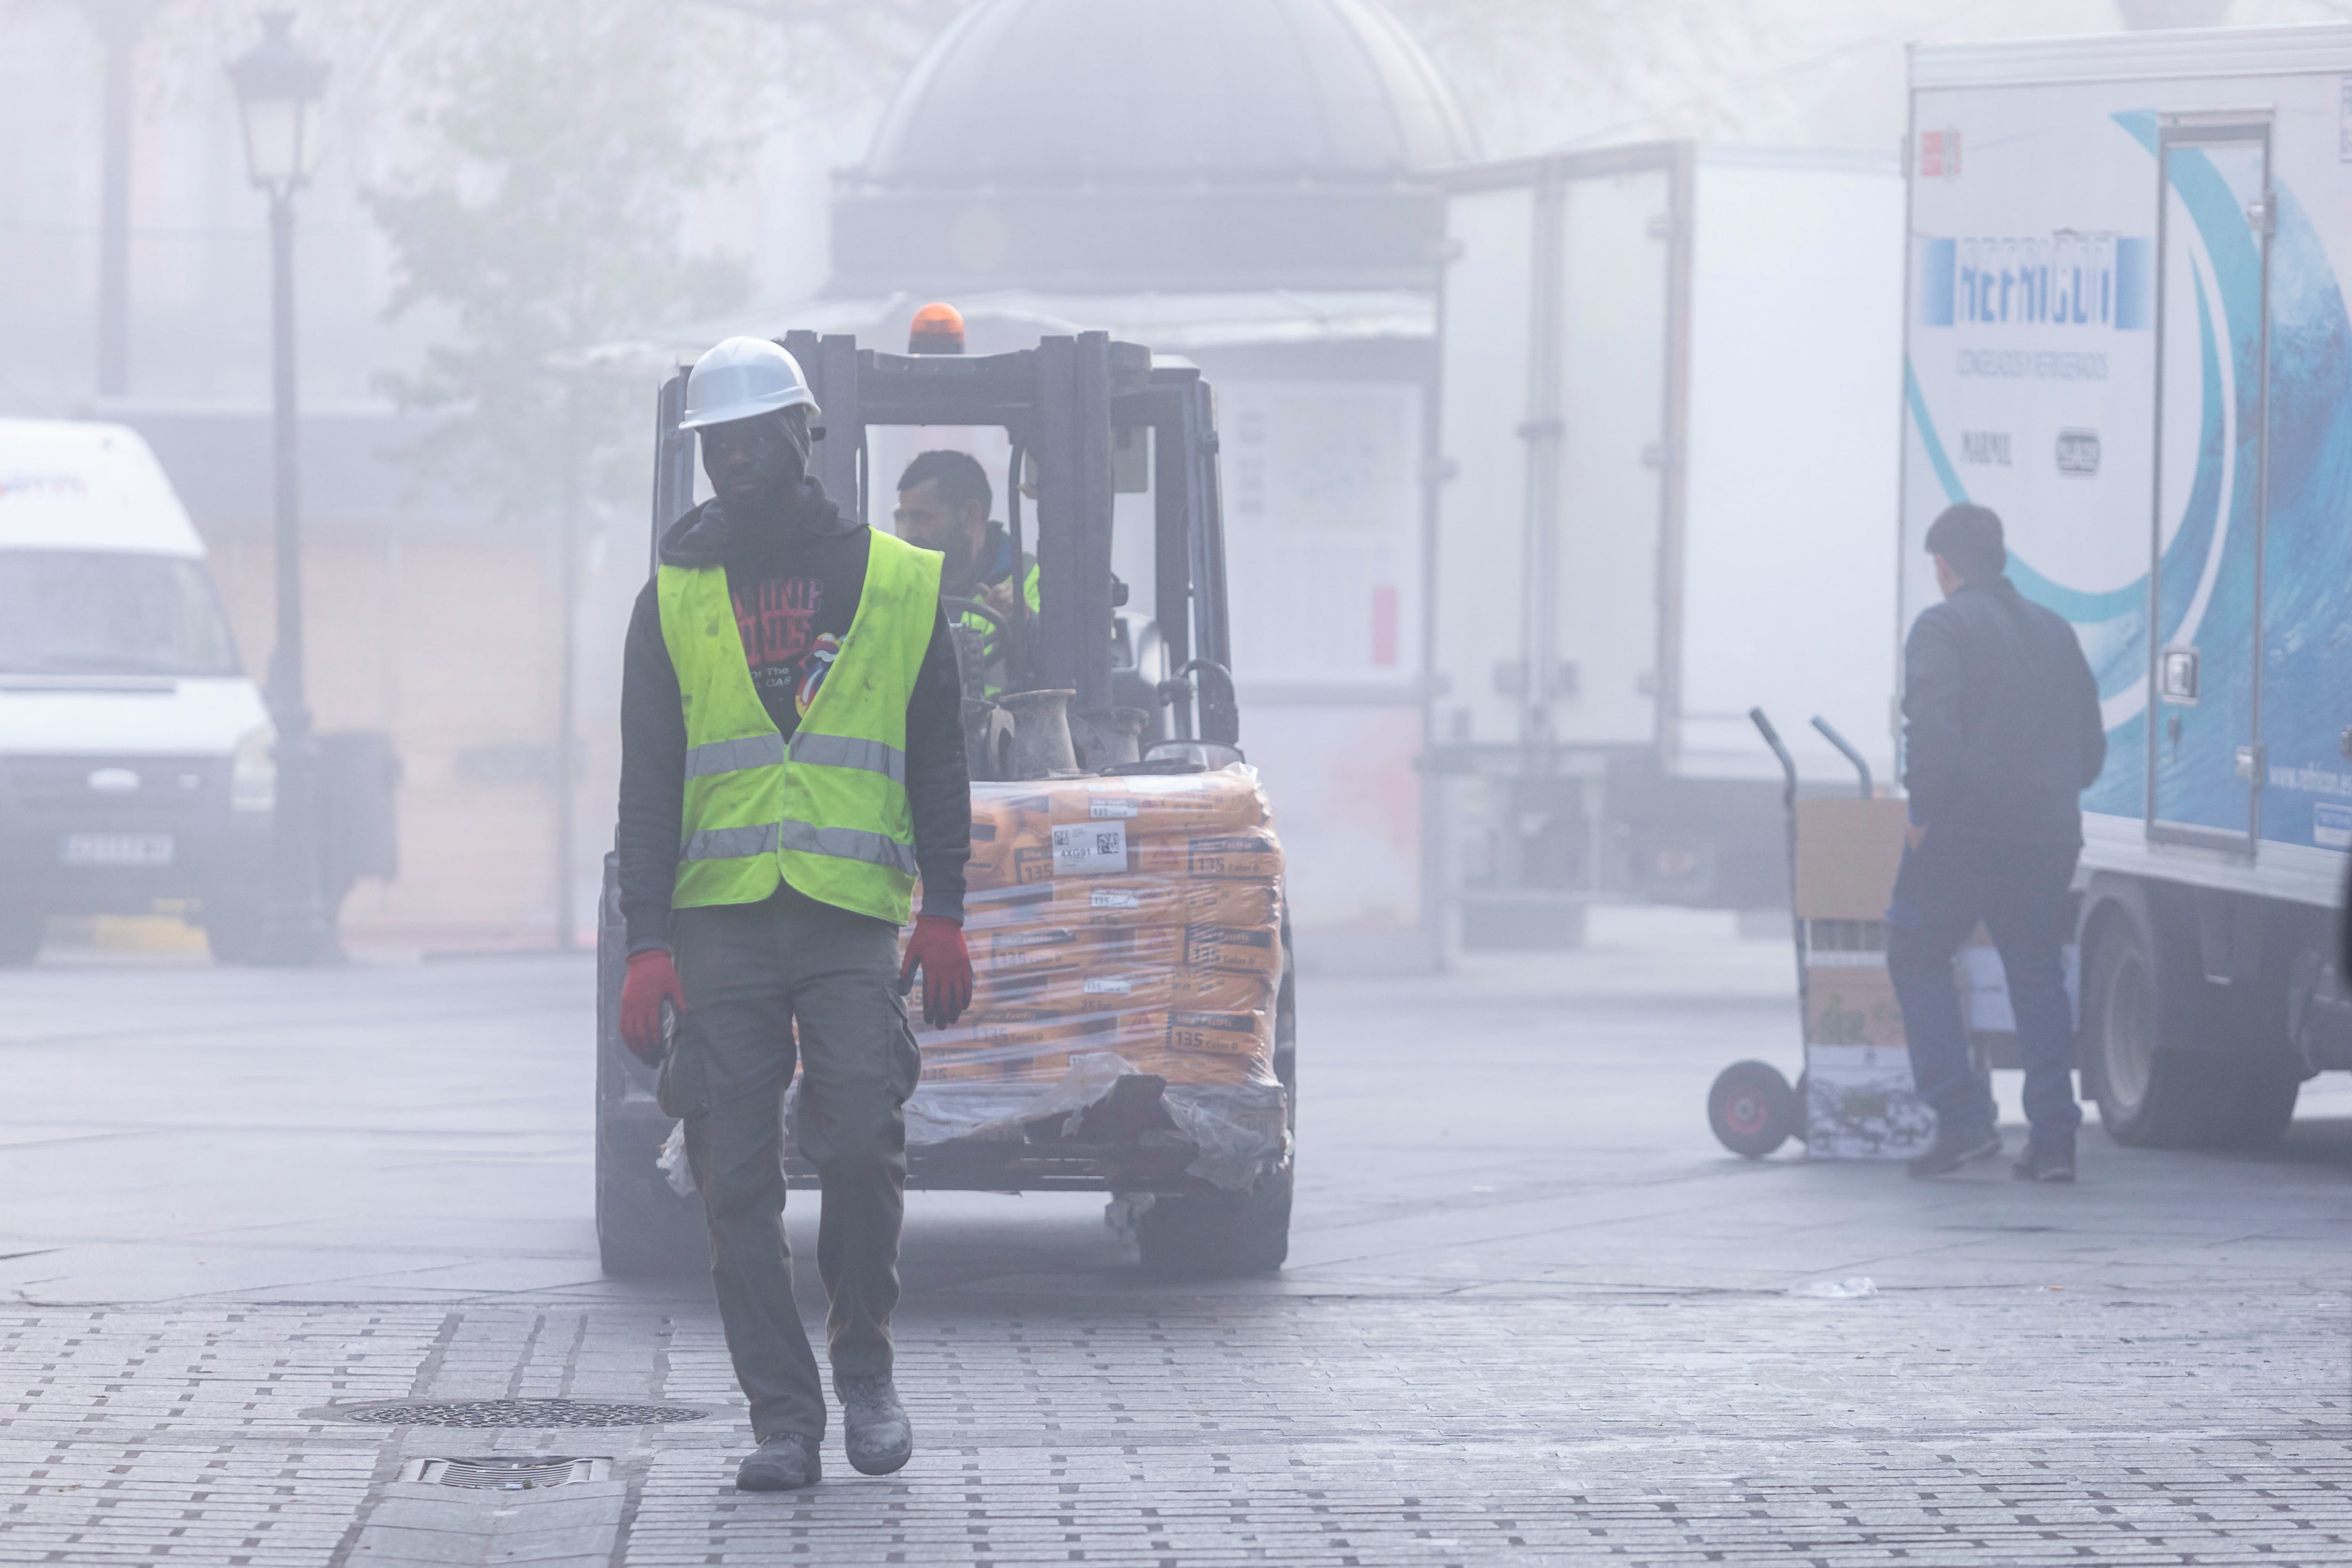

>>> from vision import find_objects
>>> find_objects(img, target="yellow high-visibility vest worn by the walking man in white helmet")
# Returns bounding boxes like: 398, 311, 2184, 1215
656, 531, 941, 924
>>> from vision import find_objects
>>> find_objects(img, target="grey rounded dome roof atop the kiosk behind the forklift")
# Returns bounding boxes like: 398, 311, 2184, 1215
833, 0, 1472, 294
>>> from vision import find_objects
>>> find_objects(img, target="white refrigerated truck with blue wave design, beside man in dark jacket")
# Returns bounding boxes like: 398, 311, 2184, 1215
1900, 26, 2352, 1145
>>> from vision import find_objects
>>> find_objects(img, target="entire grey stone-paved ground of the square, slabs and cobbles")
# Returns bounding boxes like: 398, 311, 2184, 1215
0, 926, 2352, 1568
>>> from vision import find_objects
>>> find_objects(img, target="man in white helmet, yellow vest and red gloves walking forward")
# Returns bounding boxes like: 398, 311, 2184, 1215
616, 339, 971, 1490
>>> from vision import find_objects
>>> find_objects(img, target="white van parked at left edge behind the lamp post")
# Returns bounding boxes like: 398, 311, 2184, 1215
0, 418, 278, 964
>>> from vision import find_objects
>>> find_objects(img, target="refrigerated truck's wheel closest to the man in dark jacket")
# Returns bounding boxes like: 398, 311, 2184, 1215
2082, 898, 2230, 1150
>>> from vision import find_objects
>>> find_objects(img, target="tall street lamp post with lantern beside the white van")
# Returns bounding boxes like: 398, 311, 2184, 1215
228, 12, 336, 964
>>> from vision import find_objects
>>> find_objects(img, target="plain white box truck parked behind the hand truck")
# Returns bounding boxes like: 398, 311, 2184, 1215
1423, 141, 1903, 947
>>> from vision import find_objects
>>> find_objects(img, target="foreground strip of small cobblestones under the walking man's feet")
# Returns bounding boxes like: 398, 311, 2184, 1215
0, 1288, 2352, 1566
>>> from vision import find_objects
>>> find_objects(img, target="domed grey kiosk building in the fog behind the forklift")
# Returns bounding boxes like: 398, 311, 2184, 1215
818, 0, 1477, 969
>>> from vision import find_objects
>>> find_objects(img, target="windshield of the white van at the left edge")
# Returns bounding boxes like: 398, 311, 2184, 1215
0, 550, 242, 675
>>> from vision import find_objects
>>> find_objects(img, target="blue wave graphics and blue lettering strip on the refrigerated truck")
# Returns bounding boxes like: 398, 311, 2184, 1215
1905, 113, 2352, 846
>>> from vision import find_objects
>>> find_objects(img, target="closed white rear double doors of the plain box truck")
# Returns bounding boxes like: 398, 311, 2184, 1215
1437, 148, 1675, 750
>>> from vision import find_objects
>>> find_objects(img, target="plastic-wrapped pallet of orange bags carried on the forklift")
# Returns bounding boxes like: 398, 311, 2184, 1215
856, 764, 1289, 1187
